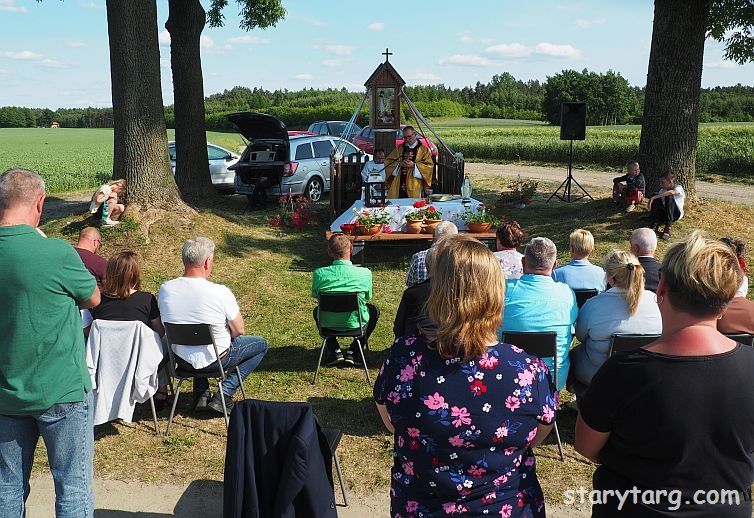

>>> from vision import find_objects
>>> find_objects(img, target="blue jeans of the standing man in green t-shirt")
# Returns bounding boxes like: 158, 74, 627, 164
0, 392, 94, 518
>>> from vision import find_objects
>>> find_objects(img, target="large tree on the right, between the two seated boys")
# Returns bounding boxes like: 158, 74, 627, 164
639, 0, 754, 196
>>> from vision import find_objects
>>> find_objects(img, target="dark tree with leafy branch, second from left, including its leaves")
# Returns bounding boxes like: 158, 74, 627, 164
165, 0, 285, 200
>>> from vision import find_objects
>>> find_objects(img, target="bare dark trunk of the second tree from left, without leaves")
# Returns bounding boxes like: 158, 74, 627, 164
165, 0, 215, 200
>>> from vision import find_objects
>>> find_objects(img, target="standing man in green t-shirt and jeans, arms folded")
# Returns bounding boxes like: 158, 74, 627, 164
0, 169, 100, 518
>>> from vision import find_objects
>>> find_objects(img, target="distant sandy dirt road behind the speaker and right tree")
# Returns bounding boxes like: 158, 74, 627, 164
466, 162, 754, 205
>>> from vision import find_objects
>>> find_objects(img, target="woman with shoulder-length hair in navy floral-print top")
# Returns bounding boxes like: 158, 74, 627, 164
374, 235, 557, 517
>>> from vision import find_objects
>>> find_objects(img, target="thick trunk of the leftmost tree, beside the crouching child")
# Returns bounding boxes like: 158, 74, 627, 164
107, 0, 182, 210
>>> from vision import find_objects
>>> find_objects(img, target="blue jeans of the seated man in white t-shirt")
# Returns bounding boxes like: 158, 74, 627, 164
189, 336, 269, 398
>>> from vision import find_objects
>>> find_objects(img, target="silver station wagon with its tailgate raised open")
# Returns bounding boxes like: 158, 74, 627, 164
228, 112, 368, 202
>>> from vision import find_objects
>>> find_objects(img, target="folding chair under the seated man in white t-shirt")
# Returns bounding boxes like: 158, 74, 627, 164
164, 322, 246, 436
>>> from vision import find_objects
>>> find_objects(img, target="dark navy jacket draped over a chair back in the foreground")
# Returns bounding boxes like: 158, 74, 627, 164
223, 399, 338, 518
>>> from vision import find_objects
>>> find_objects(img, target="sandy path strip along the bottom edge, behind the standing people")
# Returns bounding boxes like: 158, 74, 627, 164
27, 474, 591, 518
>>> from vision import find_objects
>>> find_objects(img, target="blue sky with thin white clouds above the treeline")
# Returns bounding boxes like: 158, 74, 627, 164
0, 0, 754, 108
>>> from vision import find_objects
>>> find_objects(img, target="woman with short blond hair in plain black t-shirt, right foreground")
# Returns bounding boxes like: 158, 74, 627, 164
576, 232, 754, 518
